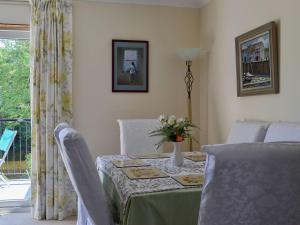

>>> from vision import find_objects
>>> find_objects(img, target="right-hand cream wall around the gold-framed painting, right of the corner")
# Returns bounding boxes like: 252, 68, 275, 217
199, 0, 300, 143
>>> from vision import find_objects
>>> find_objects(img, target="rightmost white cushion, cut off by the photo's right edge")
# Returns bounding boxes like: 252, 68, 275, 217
264, 122, 300, 142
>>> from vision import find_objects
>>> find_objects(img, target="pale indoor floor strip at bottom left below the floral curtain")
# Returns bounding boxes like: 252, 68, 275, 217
0, 213, 76, 225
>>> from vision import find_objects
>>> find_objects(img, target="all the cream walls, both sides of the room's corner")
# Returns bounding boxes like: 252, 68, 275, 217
0, 0, 300, 156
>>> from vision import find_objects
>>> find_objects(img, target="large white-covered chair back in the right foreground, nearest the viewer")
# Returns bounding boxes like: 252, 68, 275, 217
198, 143, 300, 225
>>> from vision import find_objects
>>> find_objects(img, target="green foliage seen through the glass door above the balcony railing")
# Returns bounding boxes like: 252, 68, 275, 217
0, 39, 30, 119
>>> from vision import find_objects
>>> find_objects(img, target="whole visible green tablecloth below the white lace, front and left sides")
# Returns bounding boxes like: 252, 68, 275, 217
99, 162, 201, 225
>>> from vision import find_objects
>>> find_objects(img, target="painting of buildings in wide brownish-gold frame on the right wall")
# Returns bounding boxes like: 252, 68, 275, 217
235, 22, 279, 96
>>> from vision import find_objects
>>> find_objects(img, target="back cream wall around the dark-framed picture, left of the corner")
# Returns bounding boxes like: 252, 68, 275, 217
73, 1, 200, 157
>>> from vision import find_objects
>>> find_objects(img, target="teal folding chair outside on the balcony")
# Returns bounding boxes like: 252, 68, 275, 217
0, 129, 17, 185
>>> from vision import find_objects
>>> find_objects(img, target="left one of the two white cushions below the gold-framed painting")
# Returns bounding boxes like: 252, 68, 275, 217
226, 121, 269, 144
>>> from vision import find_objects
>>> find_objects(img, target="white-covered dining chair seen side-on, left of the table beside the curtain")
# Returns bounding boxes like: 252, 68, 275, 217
54, 123, 113, 225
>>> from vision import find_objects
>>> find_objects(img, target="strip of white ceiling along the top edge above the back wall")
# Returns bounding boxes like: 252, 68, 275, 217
88, 0, 210, 8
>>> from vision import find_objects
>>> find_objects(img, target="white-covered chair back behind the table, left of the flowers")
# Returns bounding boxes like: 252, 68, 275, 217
117, 119, 161, 154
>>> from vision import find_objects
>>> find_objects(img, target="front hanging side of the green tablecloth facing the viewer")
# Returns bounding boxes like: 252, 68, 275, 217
122, 188, 200, 225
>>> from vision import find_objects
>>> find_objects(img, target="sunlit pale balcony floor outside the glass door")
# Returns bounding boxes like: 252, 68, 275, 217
0, 179, 31, 202
